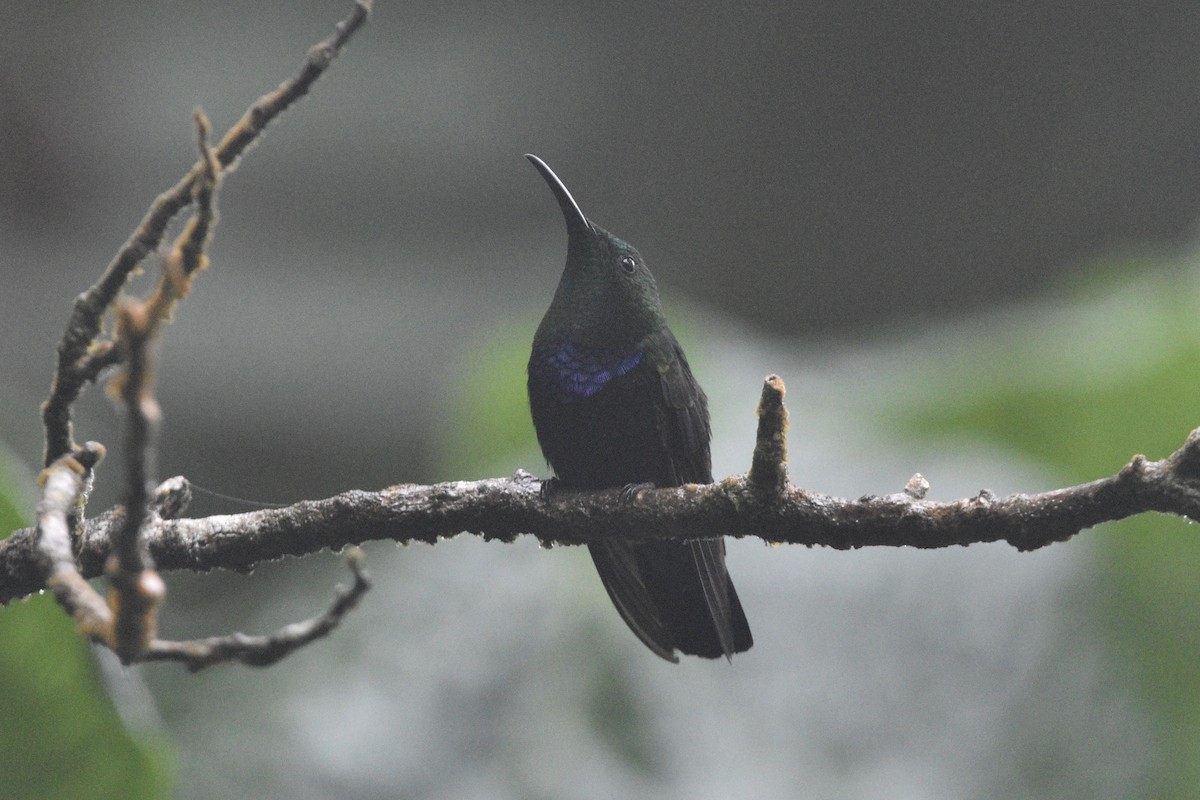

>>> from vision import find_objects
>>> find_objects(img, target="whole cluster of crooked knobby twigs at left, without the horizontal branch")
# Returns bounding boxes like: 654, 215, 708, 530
19, 0, 370, 669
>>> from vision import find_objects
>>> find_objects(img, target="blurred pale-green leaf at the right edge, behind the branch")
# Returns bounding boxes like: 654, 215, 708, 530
896, 261, 1200, 798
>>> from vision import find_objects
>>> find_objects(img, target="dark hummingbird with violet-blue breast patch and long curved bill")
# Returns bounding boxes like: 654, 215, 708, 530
526, 155, 754, 662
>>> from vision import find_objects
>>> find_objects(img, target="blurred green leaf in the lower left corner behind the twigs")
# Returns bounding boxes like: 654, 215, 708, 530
0, 450, 168, 800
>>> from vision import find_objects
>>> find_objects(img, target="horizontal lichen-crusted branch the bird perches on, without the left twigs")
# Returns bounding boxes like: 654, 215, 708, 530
9, 378, 1200, 602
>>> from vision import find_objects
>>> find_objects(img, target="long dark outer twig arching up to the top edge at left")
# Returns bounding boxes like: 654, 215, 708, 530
42, 0, 372, 467
